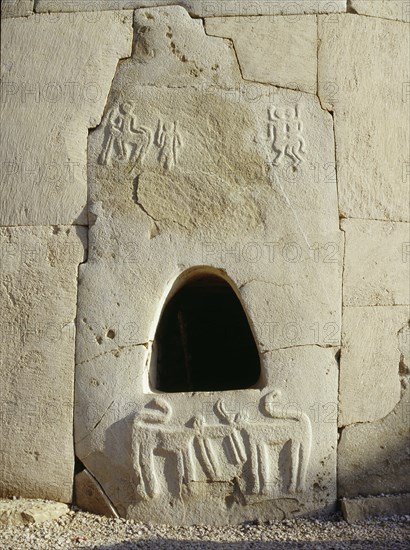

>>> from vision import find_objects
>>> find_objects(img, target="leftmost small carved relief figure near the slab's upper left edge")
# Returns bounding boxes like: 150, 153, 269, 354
99, 101, 152, 164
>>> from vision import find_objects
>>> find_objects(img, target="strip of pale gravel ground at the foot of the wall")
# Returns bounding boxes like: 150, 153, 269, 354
0, 511, 410, 550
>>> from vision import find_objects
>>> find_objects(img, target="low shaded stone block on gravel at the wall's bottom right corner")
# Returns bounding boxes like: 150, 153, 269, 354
341, 494, 410, 523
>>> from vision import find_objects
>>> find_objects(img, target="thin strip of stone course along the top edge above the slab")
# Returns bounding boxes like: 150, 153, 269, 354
36, 0, 346, 17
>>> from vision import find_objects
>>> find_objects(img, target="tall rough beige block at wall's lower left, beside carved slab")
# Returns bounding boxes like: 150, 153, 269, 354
0, 227, 86, 502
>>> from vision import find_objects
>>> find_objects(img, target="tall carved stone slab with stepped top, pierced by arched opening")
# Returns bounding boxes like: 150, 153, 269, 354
75, 7, 342, 523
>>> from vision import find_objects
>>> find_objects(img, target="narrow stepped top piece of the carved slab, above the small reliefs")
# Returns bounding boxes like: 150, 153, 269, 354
117, 7, 242, 88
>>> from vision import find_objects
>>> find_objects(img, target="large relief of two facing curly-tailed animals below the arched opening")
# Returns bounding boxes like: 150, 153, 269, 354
132, 391, 312, 499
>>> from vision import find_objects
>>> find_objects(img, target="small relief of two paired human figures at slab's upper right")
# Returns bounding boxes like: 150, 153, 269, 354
268, 105, 306, 168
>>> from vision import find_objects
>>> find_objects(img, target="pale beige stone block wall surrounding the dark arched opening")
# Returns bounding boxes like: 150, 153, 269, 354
0, 0, 410, 523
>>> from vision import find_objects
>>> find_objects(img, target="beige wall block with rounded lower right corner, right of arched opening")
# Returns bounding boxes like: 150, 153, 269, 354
339, 306, 410, 426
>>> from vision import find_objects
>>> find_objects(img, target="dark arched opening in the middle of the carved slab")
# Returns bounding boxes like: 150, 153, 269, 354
152, 275, 260, 392
